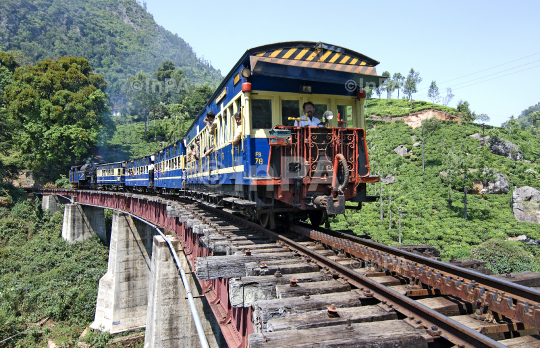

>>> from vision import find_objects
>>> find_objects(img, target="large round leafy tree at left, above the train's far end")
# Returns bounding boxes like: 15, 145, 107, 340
5, 57, 109, 179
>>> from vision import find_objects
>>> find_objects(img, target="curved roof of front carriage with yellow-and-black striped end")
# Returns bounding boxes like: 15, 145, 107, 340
186, 41, 384, 134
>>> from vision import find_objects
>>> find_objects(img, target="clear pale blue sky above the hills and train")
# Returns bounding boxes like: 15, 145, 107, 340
144, 0, 540, 126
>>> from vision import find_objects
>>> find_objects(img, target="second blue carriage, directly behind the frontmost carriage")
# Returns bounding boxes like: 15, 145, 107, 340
154, 140, 186, 193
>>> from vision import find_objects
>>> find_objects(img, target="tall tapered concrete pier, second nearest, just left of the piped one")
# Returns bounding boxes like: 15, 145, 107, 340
90, 211, 152, 333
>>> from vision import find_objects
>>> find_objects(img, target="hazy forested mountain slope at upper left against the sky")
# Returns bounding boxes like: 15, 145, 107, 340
0, 0, 222, 103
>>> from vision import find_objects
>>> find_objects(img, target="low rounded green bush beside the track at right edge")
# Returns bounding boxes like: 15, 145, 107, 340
472, 239, 540, 274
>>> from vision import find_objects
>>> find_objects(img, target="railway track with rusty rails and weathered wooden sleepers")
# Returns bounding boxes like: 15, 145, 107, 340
35, 192, 540, 348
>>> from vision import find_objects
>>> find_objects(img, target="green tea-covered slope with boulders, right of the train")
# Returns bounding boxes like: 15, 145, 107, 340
332, 115, 540, 270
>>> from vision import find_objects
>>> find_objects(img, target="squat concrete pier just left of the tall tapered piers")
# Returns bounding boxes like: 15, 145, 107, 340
62, 204, 108, 244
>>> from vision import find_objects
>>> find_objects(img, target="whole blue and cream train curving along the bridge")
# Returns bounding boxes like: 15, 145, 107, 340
69, 41, 384, 228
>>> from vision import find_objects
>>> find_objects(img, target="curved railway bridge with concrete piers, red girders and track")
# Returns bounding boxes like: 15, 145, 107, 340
34, 190, 540, 348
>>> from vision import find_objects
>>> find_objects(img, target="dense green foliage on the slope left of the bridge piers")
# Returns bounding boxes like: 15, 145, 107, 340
0, 200, 108, 347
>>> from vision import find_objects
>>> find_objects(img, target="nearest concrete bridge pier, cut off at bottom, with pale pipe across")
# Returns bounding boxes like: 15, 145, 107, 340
144, 236, 227, 348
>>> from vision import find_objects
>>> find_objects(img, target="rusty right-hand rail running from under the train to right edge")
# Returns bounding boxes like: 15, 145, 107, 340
289, 224, 540, 329
